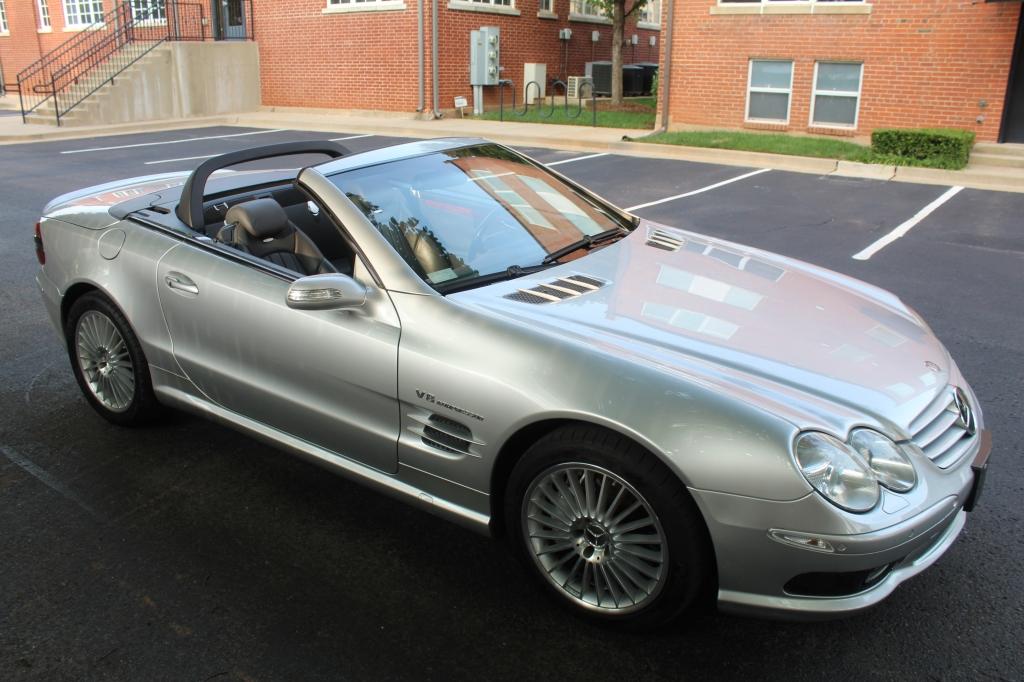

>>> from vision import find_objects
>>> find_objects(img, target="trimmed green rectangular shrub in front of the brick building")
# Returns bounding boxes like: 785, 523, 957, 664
871, 128, 974, 170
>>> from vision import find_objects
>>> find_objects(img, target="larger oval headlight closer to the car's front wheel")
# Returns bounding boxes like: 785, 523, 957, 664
796, 431, 881, 512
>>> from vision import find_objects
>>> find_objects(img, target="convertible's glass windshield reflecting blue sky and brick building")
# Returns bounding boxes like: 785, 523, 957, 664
330, 144, 632, 289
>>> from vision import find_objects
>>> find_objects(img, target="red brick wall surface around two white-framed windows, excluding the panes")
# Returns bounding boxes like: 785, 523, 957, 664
669, 0, 1021, 140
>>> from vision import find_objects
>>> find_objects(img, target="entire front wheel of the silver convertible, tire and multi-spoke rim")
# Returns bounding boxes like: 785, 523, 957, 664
505, 425, 715, 631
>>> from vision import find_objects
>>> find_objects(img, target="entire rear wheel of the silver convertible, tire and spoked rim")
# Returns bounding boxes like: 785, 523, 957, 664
65, 292, 160, 426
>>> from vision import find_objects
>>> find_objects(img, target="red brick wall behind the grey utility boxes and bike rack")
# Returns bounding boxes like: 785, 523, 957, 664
254, 0, 660, 112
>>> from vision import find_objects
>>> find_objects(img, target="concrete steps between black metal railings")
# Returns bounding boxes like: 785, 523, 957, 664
26, 45, 170, 126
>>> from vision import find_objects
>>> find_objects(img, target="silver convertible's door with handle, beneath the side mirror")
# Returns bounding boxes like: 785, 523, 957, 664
157, 243, 399, 473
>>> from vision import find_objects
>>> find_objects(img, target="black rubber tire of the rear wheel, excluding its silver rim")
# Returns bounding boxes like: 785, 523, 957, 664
65, 292, 157, 426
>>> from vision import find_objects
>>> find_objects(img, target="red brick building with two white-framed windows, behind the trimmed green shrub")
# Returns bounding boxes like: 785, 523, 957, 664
669, 0, 1024, 141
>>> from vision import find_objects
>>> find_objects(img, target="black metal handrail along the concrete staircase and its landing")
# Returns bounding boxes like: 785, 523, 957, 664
17, 0, 254, 126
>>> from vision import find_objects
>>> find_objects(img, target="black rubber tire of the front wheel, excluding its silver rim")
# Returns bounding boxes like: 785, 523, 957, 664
505, 426, 714, 631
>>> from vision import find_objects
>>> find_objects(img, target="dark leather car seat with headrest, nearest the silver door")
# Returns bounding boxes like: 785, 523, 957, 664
217, 199, 338, 274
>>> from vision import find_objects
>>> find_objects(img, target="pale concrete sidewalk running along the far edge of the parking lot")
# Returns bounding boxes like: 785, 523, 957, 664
0, 103, 1024, 193
